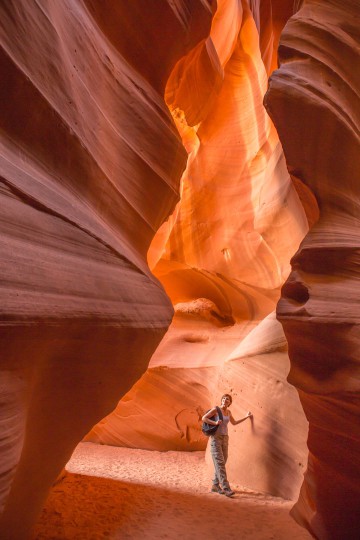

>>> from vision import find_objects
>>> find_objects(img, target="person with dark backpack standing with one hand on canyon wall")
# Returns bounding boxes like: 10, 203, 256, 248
202, 394, 253, 497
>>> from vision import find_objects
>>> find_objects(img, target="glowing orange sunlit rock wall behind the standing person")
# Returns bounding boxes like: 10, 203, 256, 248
87, 1, 310, 498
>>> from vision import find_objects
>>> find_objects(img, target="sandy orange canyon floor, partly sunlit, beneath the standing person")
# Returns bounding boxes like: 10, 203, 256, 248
35, 443, 311, 540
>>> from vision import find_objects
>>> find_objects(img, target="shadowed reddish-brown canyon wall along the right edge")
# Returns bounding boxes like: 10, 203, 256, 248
266, 0, 360, 539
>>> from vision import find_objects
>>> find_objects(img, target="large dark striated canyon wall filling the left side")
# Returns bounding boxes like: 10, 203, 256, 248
0, 0, 212, 540
